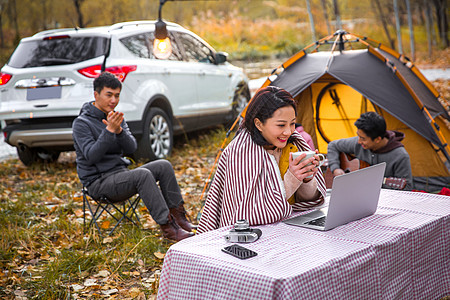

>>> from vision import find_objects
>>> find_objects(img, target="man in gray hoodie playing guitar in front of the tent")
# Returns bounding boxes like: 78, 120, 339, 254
328, 112, 413, 190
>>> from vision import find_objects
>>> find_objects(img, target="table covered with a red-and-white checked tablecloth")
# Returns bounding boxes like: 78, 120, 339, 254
158, 190, 450, 299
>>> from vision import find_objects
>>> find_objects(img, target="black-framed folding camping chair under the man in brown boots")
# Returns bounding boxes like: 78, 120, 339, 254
82, 186, 141, 236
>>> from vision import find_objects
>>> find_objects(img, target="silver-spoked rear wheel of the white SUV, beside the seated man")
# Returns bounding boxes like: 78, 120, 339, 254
135, 107, 173, 160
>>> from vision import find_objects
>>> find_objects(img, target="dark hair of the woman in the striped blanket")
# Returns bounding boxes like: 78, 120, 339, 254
241, 86, 297, 146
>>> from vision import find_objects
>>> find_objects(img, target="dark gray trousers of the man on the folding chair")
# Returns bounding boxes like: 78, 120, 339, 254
88, 159, 183, 224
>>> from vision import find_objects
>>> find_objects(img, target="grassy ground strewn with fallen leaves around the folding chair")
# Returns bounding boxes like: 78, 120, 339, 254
0, 131, 225, 299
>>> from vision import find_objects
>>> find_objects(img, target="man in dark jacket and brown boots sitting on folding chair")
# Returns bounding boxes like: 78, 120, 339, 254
72, 72, 193, 241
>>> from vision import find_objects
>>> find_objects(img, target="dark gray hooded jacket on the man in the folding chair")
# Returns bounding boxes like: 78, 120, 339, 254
72, 102, 137, 186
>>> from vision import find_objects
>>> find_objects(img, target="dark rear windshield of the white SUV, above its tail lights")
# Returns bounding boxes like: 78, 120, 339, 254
8, 36, 108, 68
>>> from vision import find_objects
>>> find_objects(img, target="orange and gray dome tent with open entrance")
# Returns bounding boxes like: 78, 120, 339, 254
202, 30, 450, 197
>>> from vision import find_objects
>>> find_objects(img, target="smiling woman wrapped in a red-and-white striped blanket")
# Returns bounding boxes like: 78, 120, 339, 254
197, 86, 326, 233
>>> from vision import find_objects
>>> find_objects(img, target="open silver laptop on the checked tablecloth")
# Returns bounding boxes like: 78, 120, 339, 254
283, 162, 386, 230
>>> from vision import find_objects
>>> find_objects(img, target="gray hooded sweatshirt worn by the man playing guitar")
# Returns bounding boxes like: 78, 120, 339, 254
327, 130, 413, 190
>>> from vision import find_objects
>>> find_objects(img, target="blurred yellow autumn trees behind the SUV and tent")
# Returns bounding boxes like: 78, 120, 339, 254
0, 0, 449, 65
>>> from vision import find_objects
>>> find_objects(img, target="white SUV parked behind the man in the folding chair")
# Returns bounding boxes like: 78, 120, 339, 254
0, 21, 250, 165
